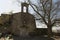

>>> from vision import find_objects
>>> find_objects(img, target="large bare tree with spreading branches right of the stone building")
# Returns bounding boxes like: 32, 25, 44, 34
28, 0, 59, 37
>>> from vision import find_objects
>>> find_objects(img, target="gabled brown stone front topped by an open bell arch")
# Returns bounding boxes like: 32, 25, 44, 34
11, 3, 36, 36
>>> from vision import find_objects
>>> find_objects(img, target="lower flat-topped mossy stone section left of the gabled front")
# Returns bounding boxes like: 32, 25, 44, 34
0, 14, 11, 33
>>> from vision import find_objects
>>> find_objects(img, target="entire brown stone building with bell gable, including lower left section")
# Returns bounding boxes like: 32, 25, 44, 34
0, 3, 36, 36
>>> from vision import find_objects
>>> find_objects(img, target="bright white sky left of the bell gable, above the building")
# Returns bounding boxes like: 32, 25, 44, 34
0, 0, 20, 13
